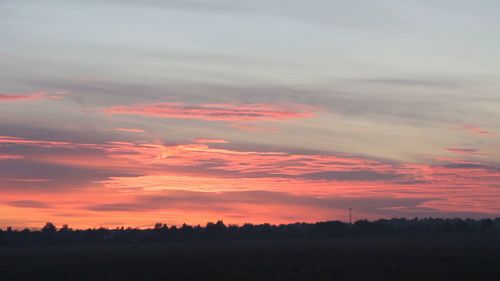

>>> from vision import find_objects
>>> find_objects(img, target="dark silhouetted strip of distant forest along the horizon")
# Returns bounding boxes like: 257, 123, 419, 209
0, 217, 500, 246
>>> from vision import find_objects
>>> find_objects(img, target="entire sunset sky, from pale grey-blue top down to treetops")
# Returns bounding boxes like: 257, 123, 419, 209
0, 0, 500, 228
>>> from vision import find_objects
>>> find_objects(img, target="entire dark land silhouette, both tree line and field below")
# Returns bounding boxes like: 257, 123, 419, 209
0, 218, 500, 281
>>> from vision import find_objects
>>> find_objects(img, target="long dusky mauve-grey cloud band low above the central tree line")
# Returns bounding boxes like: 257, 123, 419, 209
86, 191, 432, 215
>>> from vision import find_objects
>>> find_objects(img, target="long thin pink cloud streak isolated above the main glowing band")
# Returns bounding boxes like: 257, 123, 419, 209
106, 103, 313, 122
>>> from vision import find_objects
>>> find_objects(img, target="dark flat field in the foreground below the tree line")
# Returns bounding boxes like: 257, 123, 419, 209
0, 235, 500, 281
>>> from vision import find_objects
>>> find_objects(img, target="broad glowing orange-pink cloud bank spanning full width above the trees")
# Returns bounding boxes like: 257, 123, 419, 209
0, 133, 500, 227
